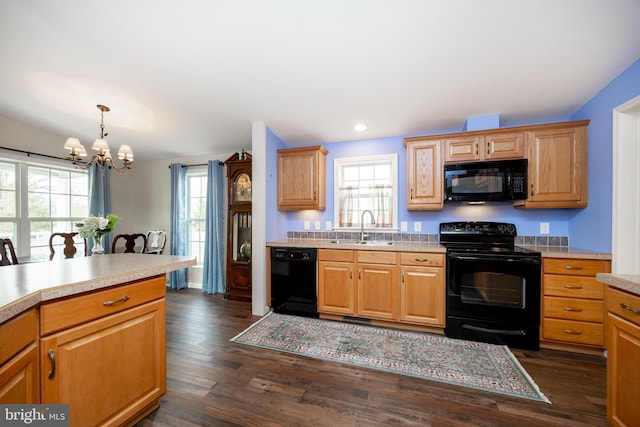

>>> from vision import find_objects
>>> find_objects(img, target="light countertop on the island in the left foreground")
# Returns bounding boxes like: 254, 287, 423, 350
0, 254, 196, 323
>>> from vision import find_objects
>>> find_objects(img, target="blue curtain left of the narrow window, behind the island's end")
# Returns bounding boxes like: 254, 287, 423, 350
169, 163, 187, 289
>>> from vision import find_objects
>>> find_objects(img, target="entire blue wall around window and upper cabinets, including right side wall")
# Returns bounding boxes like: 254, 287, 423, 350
267, 56, 640, 253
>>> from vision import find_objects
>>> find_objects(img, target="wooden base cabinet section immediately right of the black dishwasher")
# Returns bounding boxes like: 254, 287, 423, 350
318, 249, 356, 316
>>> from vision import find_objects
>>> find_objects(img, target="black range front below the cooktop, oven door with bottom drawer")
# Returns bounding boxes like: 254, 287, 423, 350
445, 251, 540, 349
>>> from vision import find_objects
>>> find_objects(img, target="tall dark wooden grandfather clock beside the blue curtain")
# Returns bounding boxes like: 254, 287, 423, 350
224, 150, 251, 301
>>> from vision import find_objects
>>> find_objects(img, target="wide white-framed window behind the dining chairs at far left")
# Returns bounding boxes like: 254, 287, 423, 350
0, 160, 89, 256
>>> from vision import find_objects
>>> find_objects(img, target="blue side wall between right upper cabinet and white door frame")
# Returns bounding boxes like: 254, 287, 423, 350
569, 60, 640, 252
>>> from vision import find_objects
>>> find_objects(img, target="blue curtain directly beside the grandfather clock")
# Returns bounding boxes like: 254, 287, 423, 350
202, 160, 225, 294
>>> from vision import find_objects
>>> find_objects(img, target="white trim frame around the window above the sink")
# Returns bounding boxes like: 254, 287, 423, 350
333, 154, 399, 232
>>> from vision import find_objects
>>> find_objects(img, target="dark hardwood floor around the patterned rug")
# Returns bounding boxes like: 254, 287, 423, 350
138, 289, 608, 427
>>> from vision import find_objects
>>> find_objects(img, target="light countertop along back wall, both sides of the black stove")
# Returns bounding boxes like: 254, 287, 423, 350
267, 239, 611, 260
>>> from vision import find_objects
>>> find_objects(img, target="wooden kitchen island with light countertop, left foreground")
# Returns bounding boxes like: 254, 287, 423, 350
0, 254, 196, 426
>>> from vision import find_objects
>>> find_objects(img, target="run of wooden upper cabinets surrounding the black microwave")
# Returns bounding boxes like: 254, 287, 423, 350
404, 120, 589, 210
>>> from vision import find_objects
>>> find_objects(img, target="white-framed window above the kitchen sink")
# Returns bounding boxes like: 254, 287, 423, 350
334, 154, 398, 231
